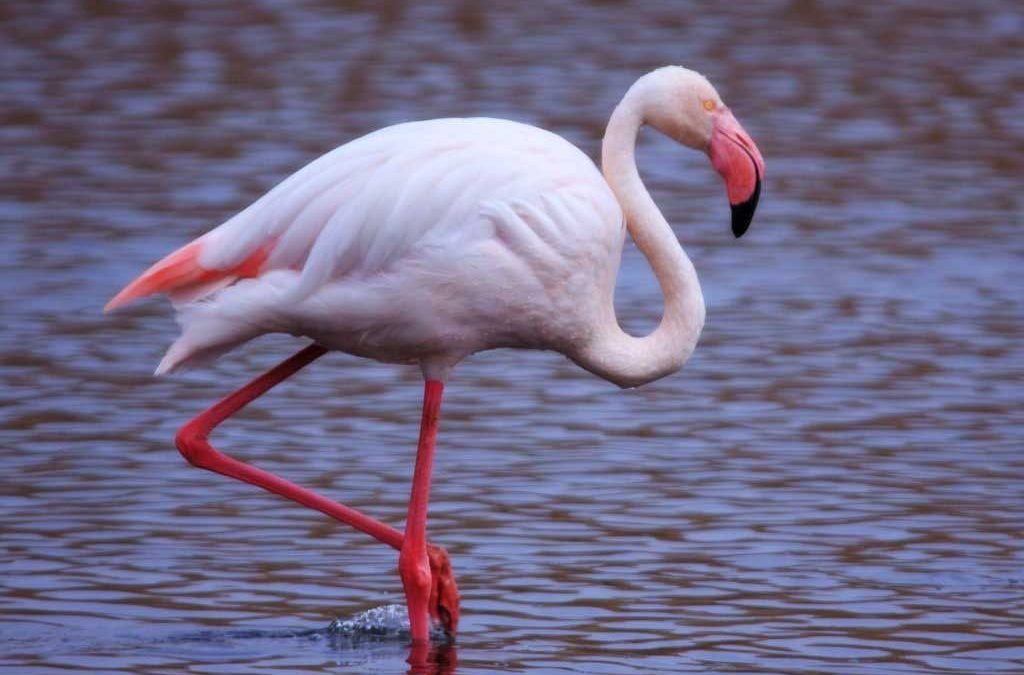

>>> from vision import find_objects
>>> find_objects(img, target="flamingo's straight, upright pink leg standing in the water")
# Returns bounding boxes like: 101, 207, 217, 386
398, 380, 444, 642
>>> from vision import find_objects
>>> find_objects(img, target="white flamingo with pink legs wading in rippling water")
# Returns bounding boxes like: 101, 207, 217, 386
105, 66, 764, 644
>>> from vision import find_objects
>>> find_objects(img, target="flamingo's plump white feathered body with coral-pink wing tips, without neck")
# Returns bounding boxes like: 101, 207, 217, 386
111, 119, 626, 373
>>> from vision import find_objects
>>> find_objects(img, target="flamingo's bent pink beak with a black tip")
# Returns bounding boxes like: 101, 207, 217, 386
708, 107, 765, 239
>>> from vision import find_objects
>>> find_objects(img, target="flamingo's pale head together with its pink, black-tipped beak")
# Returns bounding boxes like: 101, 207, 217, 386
634, 66, 765, 238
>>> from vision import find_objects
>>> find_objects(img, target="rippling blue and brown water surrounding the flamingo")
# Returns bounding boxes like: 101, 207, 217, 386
0, 0, 1024, 674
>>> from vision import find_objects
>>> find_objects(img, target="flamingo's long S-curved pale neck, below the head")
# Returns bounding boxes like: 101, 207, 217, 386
578, 89, 705, 387
